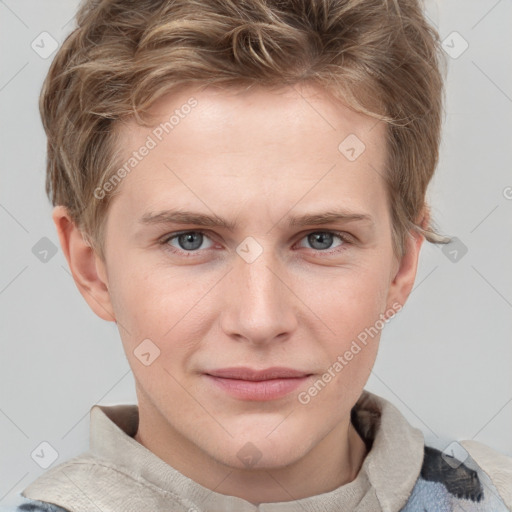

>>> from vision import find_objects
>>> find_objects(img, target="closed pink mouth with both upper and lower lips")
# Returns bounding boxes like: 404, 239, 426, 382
204, 367, 313, 401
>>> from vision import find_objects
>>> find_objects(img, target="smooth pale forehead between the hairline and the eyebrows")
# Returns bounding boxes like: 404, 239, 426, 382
109, 85, 386, 222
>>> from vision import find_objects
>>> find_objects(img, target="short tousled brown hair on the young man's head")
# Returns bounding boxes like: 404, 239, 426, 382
40, 0, 449, 258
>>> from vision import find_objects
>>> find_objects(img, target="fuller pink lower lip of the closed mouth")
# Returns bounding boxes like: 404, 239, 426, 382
206, 375, 309, 401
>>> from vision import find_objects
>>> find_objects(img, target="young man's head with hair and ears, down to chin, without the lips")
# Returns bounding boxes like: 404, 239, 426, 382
46, 0, 448, 478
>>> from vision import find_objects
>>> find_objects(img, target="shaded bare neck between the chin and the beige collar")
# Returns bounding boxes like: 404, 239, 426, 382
134, 405, 367, 505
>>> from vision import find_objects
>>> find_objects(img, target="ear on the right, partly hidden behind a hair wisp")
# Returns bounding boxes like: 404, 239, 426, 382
387, 210, 430, 311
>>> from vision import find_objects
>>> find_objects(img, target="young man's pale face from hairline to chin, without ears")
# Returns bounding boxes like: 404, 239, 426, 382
90, 86, 408, 468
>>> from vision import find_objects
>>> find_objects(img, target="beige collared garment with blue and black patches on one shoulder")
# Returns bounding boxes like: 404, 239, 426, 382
16, 391, 512, 512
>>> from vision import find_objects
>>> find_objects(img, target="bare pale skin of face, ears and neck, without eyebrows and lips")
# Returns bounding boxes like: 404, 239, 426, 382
53, 84, 423, 503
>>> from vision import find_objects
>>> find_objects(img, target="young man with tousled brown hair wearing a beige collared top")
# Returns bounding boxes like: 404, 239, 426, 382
12, 0, 512, 512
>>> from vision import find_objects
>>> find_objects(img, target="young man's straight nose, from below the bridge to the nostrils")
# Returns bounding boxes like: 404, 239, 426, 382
221, 242, 300, 345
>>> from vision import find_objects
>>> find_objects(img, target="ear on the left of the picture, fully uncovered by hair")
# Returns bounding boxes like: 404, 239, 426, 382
52, 206, 115, 322
